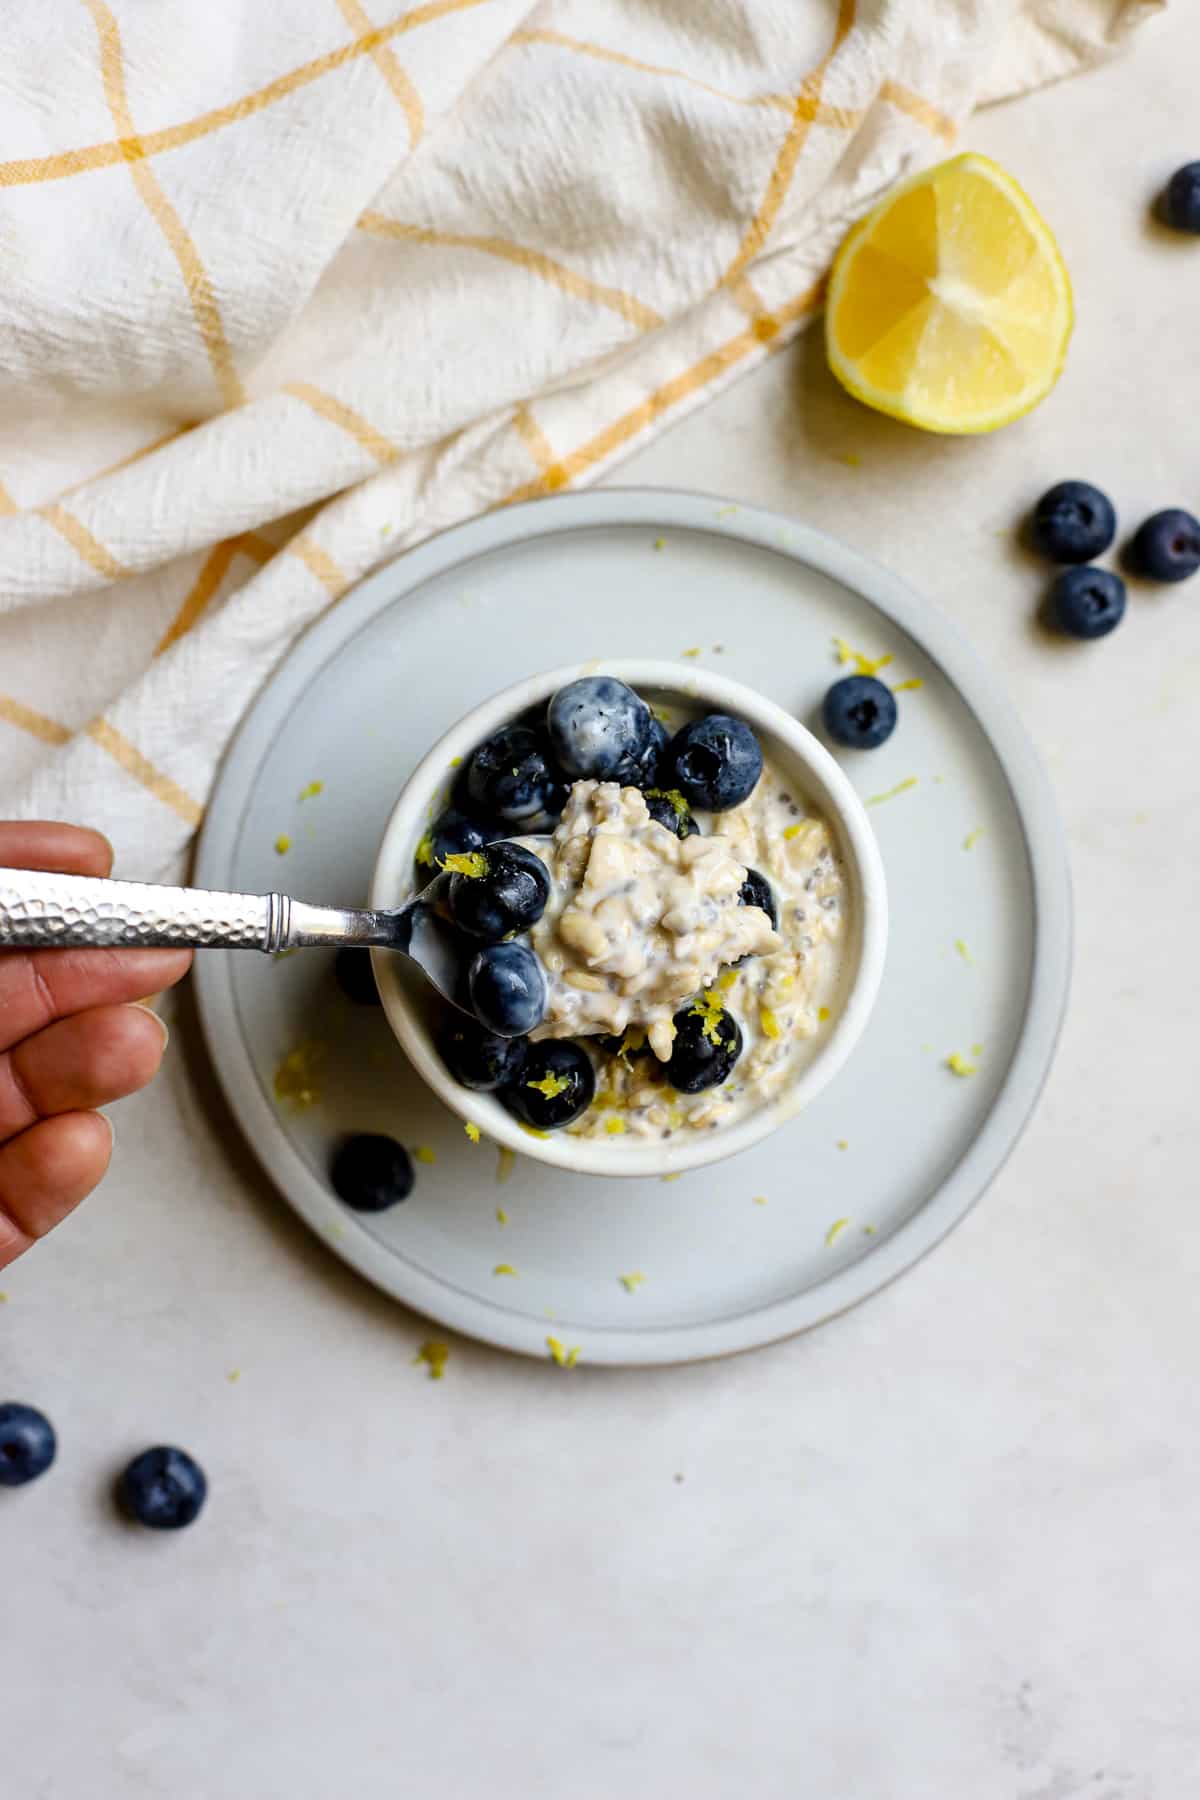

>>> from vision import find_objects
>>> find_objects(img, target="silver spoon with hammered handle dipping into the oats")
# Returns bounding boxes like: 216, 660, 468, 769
0, 869, 479, 1012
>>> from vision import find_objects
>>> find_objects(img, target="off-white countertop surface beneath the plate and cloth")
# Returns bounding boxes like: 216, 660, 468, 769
0, 21, 1200, 1800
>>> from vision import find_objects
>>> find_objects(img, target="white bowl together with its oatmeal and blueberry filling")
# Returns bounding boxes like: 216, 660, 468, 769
371, 661, 887, 1175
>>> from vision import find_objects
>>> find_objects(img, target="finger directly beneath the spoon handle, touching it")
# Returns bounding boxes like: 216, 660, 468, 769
0, 950, 193, 1051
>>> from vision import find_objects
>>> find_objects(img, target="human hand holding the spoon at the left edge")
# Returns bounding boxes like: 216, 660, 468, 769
0, 824, 191, 1269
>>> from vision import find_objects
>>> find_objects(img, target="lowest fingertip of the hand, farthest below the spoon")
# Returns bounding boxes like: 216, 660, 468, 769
0, 1112, 113, 1269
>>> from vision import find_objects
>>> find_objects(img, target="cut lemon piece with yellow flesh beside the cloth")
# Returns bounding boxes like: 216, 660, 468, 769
826, 153, 1074, 432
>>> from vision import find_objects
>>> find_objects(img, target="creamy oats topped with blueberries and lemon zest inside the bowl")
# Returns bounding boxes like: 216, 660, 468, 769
417, 675, 849, 1139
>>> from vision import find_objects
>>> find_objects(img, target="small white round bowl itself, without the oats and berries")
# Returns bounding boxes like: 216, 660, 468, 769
371, 659, 887, 1175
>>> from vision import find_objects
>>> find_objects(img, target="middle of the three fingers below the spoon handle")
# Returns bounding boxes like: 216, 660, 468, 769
0, 1006, 167, 1141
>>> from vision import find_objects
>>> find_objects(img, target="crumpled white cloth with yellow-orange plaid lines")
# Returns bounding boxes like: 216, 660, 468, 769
0, 0, 1159, 877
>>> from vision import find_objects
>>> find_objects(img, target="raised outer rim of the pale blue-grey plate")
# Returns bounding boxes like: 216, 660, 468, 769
194, 486, 1072, 1366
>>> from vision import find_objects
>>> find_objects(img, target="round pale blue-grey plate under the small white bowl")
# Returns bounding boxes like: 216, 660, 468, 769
196, 490, 1070, 1364
